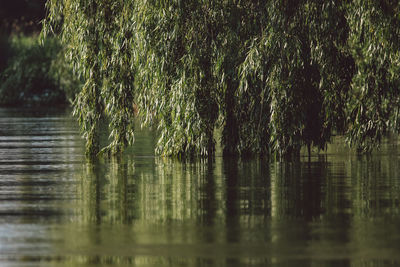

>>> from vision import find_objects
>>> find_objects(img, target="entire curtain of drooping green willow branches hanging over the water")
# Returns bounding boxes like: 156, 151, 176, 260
44, 0, 400, 156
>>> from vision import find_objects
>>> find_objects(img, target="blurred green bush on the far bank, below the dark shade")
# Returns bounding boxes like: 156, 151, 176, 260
0, 36, 80, 106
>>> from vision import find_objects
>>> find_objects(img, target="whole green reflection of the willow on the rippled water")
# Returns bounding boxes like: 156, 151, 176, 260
54, 151, 400, 267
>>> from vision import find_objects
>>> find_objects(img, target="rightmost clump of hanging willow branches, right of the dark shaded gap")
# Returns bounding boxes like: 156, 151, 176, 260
346, 0, 400, 151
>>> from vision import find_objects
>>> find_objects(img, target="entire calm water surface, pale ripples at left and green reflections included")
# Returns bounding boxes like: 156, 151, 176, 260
0, 109, 400, 267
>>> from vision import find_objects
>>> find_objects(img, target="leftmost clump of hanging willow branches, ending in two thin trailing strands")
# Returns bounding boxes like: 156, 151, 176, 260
44, 0, 135, 155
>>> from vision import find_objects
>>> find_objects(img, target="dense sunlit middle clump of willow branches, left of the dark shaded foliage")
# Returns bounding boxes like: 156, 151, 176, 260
134, 1, 219, 155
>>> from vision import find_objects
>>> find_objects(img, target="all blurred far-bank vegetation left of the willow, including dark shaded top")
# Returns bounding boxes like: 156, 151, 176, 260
0, 0, 80, 107
